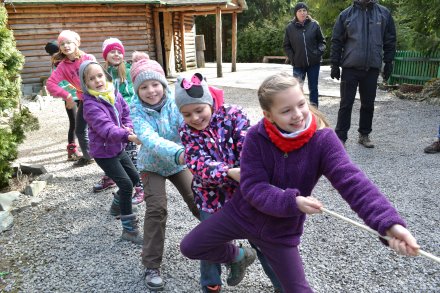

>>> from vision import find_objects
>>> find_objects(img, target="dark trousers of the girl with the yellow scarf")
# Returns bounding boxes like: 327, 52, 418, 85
95, 151, 140, 215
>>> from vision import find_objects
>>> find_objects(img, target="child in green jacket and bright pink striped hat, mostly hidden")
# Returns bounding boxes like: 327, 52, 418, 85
93, 38, 144, 204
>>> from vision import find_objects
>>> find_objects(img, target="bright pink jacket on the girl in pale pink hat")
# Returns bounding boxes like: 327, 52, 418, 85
46, 54, 96, 100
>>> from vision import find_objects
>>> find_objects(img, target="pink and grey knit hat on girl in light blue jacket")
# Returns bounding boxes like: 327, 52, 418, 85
130, 51, 168, 93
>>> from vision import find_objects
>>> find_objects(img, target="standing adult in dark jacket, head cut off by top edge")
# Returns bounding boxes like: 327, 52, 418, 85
330, 0, 396, 148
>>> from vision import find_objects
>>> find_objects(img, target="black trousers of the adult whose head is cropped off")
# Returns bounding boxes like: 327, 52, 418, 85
335, 68, 379, 142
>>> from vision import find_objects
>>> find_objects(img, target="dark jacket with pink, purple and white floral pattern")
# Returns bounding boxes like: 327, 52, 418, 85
179, 105, 250, 213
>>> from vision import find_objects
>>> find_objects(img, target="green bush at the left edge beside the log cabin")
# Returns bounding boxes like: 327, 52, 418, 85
0, 5, 39, 188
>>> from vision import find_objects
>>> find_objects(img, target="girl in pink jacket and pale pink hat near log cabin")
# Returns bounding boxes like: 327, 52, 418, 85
46, 30, 96, 167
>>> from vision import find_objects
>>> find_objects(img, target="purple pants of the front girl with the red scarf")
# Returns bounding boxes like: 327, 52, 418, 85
180, 205, 313, 293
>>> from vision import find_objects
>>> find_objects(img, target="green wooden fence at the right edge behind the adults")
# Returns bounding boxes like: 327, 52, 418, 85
388, 51, 440, 85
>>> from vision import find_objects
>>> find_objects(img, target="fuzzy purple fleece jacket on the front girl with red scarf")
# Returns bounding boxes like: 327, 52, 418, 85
223, 120, 405, 245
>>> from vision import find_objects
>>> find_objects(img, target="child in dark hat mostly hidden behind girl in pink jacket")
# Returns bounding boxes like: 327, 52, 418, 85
44, 41, 82, 161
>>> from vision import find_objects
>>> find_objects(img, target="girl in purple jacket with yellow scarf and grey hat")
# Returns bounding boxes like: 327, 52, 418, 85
79, 61, 142, 244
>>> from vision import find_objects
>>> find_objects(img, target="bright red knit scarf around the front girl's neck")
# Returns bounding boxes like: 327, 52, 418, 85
264, 113, 316, 153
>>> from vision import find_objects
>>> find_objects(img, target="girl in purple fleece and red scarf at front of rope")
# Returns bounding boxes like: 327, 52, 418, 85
180, 73, 419, 293
